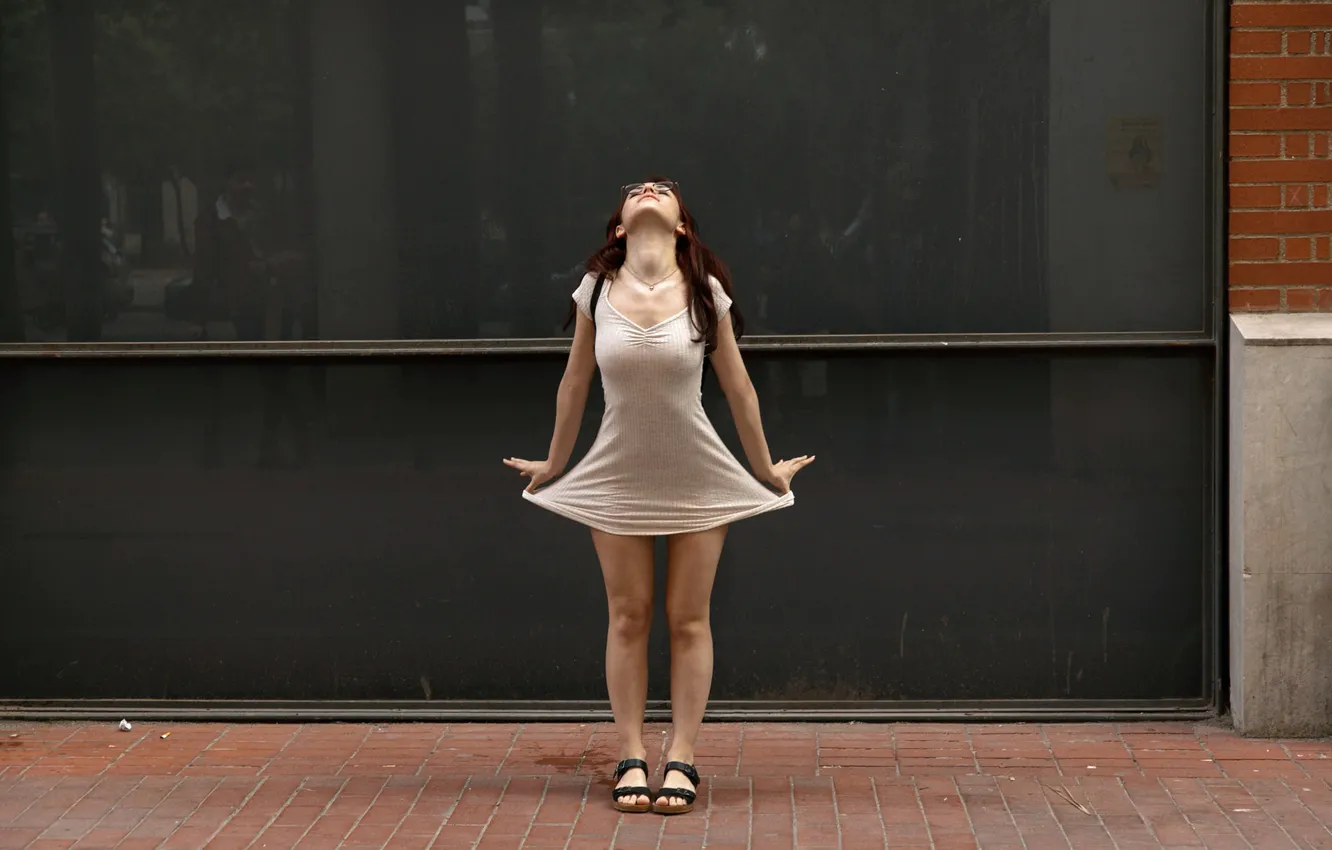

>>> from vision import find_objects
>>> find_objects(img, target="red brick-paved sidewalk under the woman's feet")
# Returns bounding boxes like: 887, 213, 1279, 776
0, 723, 1332, 850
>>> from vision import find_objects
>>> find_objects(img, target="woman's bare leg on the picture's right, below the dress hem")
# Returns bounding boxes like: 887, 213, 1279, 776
662, 526, 726, 806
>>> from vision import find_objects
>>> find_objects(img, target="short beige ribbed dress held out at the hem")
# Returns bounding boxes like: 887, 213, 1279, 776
522, 274, 795, 536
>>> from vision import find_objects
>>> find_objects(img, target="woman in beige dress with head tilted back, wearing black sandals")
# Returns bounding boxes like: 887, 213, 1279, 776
505, 180, 814, 814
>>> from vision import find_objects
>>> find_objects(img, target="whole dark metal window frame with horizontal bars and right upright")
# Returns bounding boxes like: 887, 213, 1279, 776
0, 0, 1229, 721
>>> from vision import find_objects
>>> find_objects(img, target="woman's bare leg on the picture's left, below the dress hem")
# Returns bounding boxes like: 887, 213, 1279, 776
591, 530, 653, 805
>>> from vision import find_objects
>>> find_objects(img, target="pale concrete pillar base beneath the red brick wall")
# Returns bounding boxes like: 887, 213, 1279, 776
1229, 314, 1332, 737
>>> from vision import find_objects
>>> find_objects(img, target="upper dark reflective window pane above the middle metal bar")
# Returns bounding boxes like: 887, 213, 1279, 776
0, 0, 1204, 342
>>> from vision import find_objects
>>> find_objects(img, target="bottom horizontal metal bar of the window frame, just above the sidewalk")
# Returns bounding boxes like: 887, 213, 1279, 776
0, 699, 1216, 723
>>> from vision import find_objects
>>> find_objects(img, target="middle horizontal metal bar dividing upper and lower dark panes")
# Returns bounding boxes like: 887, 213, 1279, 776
0, 332, 1216, 360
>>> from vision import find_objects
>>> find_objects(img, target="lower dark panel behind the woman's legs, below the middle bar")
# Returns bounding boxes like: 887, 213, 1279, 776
0, 353, 1209, 701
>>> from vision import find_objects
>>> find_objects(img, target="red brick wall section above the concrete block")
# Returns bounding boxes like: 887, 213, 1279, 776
1229, 0, 1332, 312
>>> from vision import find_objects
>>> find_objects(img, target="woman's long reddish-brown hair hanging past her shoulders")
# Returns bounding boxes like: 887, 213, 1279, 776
565, 177, 745, 354
